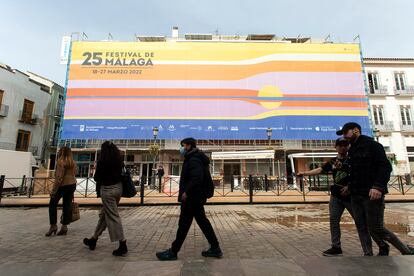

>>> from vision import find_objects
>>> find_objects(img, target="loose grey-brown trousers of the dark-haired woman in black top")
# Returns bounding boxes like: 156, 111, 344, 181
93, 183, 125, 242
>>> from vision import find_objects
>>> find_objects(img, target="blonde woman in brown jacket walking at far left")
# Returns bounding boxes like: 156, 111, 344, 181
46, 146, 76, 237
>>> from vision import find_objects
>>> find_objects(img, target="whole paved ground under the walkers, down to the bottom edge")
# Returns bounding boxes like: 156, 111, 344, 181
0, 203, 414, 276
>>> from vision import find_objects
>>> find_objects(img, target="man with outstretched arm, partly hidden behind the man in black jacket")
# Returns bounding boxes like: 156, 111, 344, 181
298, 137, 372, 256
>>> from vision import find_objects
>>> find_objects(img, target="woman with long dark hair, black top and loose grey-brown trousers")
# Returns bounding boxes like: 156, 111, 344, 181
83, 141, 128, 256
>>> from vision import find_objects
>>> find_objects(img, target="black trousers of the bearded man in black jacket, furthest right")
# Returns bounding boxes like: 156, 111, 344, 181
352, 195, 410, 254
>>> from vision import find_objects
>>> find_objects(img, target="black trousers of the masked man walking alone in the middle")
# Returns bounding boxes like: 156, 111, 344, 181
171, 199, 219, 253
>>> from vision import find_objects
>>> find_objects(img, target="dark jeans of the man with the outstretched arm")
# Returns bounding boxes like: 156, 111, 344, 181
329, 196, 353, 248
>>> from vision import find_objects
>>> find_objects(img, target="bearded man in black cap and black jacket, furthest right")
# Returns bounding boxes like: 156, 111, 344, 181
336, 122, 414, 256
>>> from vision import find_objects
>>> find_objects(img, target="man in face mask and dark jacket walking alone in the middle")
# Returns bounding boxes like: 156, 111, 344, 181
156, 138, 223, 261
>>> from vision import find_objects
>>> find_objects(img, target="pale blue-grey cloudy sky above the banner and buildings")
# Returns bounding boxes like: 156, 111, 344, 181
0, 0, 414, 85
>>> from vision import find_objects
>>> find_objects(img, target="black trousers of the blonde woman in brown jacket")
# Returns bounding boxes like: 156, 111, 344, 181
49, 184, 76, 225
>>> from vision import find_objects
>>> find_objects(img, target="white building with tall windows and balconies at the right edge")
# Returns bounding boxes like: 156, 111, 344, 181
364, 58, 414, 174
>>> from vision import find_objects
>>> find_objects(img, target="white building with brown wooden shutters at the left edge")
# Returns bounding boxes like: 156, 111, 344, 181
0, 64, 51, 163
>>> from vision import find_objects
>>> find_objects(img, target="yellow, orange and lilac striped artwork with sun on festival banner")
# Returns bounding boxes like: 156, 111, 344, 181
64, 42, 368, 139
